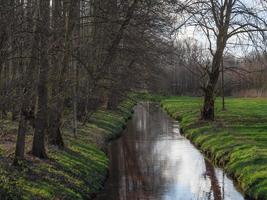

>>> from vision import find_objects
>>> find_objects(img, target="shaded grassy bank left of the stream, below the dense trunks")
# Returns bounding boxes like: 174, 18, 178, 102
0, 100, 134, 200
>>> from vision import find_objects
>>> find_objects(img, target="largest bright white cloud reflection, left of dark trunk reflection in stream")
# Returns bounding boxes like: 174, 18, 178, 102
153, 134, 214, 200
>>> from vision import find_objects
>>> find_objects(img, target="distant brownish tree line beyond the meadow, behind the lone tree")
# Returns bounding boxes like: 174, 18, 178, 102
168, 40, 267, 97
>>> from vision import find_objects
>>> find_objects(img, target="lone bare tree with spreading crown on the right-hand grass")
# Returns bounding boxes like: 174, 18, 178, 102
180, 0, 266, 120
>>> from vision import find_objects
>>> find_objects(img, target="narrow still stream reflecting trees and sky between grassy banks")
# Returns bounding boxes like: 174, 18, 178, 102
97, 103, 244, 200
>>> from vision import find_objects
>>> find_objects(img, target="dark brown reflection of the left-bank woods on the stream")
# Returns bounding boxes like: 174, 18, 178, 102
117, 105, 173, 200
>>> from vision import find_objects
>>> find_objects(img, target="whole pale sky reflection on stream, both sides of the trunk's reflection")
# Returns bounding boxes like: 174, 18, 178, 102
152, 108, 243, 200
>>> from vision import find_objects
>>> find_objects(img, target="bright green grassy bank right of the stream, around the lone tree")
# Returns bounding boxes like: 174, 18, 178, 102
161, 97, 267, 200
